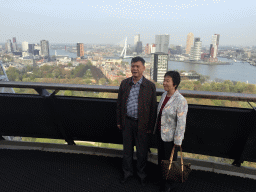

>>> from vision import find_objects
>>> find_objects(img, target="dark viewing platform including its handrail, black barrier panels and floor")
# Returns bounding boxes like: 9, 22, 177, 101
0, 82, 256, 192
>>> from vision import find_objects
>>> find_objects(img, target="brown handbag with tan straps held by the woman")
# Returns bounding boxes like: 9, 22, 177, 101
161, 145, 191, 183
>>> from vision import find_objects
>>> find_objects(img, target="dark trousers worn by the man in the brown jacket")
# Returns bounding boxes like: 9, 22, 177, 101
123, 117, 148, 179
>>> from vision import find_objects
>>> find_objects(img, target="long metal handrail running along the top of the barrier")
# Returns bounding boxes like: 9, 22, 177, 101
0, 81, 256, 102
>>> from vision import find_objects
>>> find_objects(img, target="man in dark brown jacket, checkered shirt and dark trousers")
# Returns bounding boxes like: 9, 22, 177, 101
117, 57, 156, 185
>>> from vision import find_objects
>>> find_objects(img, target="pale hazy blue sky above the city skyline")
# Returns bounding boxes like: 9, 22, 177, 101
0, 0, 256, 46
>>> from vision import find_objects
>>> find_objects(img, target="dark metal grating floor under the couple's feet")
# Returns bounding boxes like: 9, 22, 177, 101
0, 149, 256, 192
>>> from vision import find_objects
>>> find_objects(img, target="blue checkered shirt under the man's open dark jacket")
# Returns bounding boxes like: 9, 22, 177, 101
127, 77, 143, 118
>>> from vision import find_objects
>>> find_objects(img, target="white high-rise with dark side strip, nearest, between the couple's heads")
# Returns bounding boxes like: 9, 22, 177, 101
150, 53, 168, 84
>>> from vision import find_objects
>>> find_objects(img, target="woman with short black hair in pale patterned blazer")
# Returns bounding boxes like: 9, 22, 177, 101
154, 71, 188, 191
